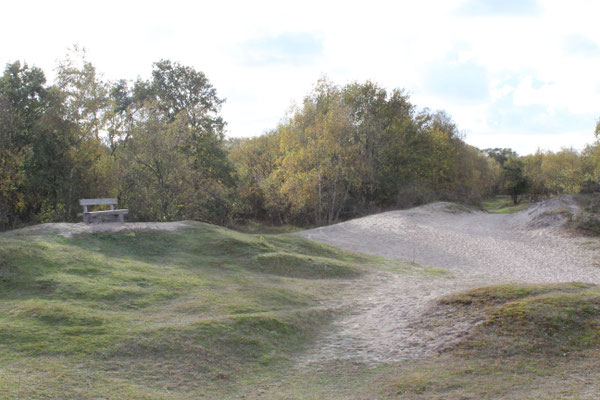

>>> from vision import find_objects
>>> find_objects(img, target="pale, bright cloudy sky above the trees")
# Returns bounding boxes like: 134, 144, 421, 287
0, 0, 600, 155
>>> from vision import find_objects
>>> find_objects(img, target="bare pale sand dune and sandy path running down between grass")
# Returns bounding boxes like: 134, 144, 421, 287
297, 196, 600, 363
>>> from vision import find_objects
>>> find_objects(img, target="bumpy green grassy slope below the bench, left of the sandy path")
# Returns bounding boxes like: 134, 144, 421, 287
0, 223, 420, 399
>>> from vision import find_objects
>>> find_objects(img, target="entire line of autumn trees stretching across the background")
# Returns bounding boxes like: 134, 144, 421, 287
0, 49, 600, 229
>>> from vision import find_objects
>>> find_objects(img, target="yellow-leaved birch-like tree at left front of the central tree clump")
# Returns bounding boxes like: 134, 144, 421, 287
279, 80, 365, 224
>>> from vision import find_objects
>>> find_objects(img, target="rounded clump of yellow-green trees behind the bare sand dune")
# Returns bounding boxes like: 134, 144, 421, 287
231, 81, 499, 224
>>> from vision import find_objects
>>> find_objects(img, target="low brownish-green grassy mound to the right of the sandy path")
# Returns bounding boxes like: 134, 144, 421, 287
442, 283, 600, 355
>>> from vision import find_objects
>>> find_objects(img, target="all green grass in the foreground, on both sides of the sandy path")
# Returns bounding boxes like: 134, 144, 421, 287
0, 223, 600, 400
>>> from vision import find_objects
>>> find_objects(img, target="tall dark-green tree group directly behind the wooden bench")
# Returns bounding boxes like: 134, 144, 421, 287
0, 51, 235, 228
